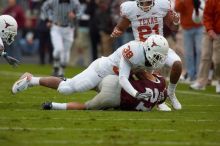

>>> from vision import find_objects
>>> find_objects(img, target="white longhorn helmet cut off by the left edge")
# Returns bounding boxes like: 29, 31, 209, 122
0, 15, 18, 45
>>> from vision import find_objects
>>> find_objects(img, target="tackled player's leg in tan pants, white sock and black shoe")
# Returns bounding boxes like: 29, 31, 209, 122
42, 75, 121, 110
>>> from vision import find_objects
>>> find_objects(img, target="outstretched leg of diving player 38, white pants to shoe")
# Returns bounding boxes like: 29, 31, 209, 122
12, 60, 102, 94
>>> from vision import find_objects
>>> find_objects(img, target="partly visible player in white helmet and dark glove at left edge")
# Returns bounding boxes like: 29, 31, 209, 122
0, 15, 19, 66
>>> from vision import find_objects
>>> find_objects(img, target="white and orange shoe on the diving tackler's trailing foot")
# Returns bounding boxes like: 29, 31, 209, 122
12, 72, 33, 94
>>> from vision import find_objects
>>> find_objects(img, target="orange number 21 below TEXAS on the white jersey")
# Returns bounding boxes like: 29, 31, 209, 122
137, 24, 159, 42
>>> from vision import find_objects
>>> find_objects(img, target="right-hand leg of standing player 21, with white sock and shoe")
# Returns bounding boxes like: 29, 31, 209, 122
166, 49, 182, 110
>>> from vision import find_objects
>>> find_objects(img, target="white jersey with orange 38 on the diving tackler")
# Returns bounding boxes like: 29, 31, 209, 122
108, 41, 145, 68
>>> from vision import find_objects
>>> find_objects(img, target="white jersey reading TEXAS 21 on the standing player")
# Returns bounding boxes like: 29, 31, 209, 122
120, 0, 171, 41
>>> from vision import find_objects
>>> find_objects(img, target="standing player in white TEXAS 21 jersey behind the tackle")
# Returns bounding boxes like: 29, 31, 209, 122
111, 0, 182, 110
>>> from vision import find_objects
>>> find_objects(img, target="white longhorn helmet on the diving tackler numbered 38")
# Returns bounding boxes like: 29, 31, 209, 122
143, 35, 169, 69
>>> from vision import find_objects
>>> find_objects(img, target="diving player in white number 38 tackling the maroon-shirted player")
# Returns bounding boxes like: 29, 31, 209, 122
12, 35, 169, 104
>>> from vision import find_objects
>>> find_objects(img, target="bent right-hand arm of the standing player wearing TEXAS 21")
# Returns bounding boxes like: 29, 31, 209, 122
163, 10, 180, 32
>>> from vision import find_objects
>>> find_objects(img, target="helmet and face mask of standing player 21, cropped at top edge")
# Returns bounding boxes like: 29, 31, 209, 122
136, 0, 154, 12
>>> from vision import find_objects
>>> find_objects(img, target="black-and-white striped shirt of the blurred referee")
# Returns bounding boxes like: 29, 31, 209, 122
41, 0, 80, 27
